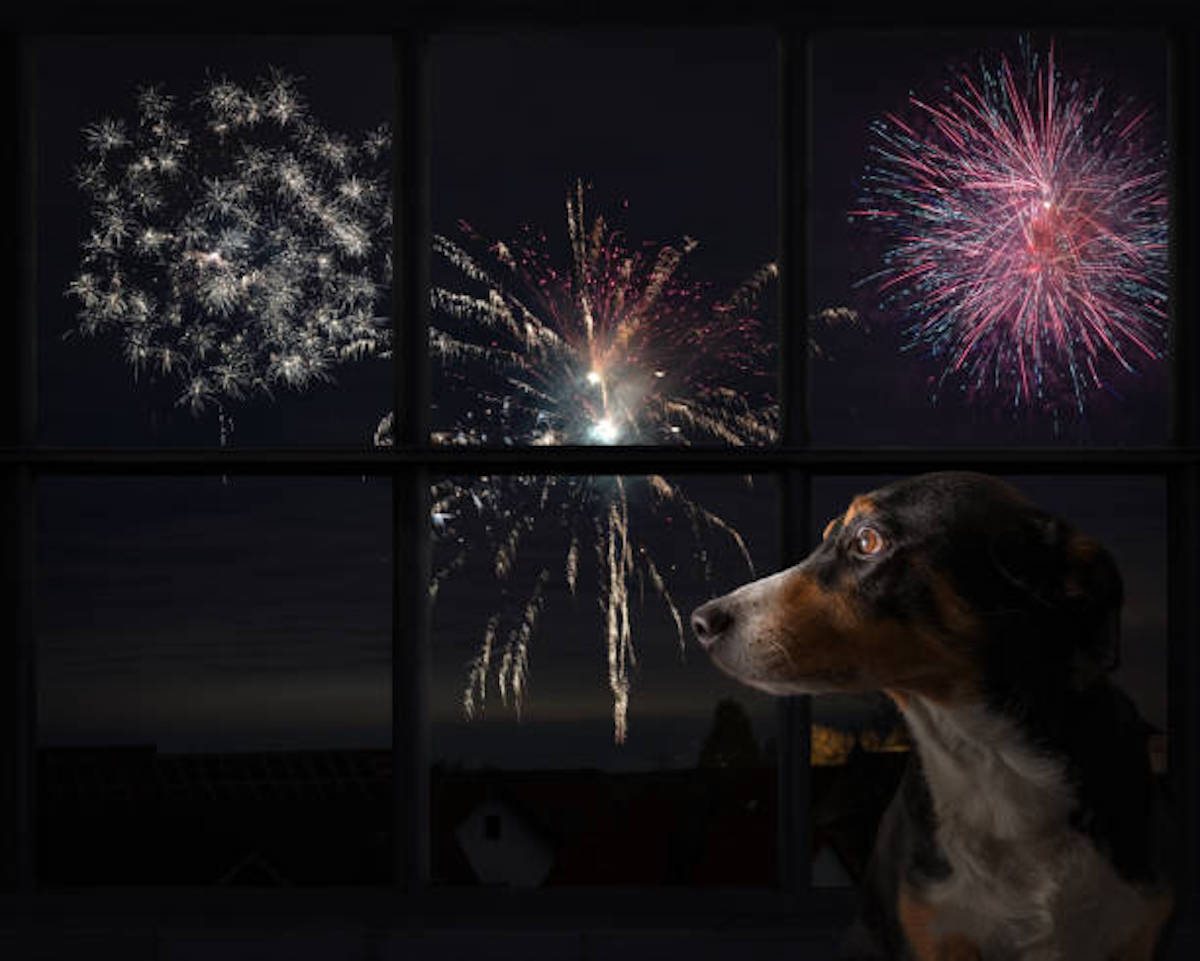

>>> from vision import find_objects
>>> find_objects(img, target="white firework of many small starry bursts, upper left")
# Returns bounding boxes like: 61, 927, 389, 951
67, 72, 391, 444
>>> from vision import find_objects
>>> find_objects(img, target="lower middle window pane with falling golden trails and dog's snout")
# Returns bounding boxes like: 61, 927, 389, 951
431, 476, 779, 887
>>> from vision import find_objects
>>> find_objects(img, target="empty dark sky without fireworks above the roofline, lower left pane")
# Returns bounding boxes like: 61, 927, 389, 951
37, 476, 391, 751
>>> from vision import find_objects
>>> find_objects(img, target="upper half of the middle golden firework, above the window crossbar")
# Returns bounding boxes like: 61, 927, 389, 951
430, 184, 778, 445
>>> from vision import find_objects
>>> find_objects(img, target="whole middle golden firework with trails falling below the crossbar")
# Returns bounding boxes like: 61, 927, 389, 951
430, 184, 779, 743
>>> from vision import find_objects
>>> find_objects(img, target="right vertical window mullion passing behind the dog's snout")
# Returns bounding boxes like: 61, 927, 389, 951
778, 24, 812, 896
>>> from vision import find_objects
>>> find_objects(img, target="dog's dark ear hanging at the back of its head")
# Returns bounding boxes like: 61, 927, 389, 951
1060, 522, 1124, 685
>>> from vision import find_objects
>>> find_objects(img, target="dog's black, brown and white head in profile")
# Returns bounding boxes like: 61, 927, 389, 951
691, 473, 1122, 702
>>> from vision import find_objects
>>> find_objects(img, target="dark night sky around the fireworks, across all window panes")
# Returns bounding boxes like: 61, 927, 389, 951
37, 31, 1165, 768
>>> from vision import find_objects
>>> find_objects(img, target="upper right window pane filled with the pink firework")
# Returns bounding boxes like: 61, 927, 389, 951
808, 32, 1170, 446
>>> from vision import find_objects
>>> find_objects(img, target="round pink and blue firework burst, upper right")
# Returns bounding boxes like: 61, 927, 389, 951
851, 41, 1168, 414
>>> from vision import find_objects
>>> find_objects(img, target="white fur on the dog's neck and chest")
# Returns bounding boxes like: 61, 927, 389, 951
905, 698, 1145, 961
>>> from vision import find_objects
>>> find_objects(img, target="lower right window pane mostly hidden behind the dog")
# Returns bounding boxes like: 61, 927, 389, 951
812, 476, 1168, 885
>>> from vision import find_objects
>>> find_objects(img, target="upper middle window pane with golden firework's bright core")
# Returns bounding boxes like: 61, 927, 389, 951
431, 30, 779, 445
